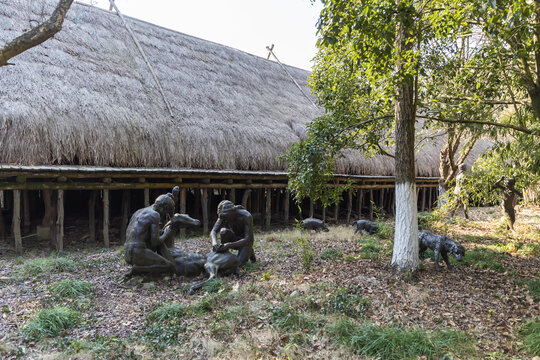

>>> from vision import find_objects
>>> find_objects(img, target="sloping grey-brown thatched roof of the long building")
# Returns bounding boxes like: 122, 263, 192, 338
0, 0, 490, 176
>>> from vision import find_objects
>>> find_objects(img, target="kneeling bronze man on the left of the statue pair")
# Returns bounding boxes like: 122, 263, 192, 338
124, 194, 175, 276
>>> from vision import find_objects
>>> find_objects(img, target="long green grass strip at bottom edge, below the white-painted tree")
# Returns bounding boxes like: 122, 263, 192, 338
329, 319, 476, 360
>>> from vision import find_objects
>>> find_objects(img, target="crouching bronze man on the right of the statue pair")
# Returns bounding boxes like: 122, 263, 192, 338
210, 200, 256, 266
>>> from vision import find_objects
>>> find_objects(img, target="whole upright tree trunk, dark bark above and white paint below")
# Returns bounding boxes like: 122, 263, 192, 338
392, 8, 419, 272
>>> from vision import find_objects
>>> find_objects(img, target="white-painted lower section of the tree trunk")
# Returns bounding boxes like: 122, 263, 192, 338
392, 183, 419, 272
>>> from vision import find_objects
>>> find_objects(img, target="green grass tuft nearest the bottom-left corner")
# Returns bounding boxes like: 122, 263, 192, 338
22, 306, 81, 340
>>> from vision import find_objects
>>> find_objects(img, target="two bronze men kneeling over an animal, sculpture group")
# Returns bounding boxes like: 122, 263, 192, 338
124, 187, 256, 293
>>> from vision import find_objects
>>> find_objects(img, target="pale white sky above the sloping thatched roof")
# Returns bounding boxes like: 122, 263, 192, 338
79, 0, 322, 70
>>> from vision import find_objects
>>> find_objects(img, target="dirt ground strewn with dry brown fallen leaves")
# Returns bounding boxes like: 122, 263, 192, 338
0, 207, 540, 359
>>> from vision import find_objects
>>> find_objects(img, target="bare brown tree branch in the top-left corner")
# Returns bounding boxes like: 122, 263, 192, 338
0, 0, 73, 66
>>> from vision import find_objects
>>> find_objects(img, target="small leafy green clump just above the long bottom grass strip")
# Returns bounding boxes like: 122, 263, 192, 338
324, 287, 369, 319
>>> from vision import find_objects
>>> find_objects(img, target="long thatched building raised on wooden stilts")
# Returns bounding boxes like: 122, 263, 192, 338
0, 0, 480, 251
